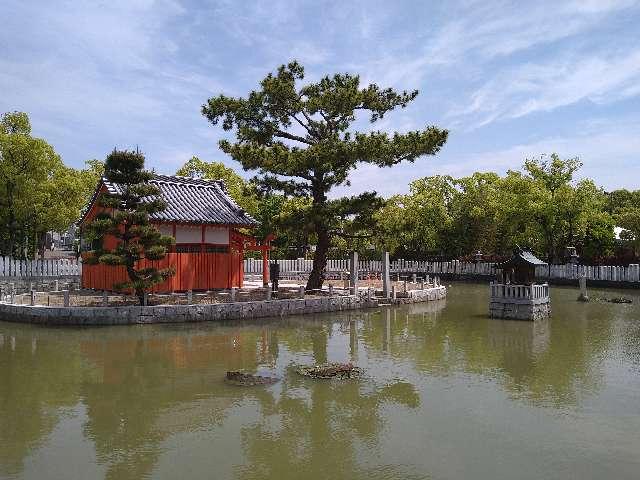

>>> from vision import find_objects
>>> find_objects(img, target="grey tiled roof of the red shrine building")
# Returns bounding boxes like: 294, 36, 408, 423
80, 175, 258, 227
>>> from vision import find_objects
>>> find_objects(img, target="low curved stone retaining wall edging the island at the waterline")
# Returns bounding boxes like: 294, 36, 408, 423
0, 286, 447, 326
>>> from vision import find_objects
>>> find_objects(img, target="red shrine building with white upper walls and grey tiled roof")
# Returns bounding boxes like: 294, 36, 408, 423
79, 175, 270, 292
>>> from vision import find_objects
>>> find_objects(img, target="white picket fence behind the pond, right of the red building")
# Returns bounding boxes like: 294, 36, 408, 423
244, 258, 640, 282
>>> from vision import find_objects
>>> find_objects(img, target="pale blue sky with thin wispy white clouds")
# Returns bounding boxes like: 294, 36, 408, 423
0, 0, 640, 196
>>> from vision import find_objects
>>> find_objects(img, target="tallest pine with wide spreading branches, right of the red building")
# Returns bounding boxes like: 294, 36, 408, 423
202, 62, 447, 289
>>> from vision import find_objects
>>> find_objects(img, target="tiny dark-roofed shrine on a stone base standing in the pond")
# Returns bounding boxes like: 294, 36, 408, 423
489, 249, 550, 320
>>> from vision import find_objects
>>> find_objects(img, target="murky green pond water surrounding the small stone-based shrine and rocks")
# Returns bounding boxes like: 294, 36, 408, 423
0, 284, 640, 480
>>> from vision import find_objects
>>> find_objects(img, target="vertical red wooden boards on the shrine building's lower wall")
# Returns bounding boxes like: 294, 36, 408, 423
82, 252, 244, 293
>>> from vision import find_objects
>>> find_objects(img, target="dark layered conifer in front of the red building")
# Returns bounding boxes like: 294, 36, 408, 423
86, 150, 174, 304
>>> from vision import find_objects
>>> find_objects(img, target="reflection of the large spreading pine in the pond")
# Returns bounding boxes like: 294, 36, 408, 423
232, 320, 420, 480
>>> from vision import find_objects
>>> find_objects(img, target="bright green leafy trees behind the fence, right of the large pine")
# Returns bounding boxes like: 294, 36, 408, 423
376, 154, 614, 262
